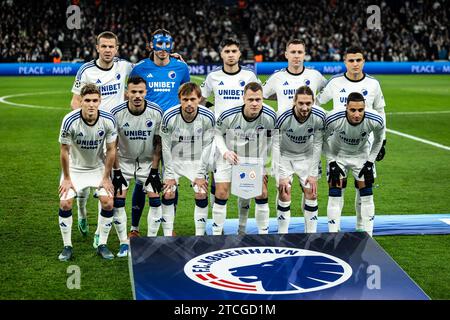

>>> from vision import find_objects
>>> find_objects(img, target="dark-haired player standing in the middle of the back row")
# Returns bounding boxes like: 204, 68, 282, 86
201, 38, 259, 234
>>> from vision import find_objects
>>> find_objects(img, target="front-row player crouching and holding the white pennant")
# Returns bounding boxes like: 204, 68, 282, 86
212, 82, 276, 235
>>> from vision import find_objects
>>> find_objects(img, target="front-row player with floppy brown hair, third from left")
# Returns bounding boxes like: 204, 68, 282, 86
160, 82, 215, 236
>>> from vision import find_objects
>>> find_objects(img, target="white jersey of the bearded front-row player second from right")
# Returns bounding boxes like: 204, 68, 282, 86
275, 106, 326, 176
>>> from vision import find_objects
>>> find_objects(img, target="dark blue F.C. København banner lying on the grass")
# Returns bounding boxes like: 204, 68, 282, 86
129, 232, 429, 300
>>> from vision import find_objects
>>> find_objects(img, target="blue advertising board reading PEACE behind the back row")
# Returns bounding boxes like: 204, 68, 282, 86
0, 61, 450, 76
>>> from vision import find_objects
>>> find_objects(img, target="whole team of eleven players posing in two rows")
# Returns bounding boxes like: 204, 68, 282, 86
59, 29, 386, 261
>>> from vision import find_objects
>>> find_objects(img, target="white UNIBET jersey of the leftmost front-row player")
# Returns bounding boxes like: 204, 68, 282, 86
59, 109, 117, 171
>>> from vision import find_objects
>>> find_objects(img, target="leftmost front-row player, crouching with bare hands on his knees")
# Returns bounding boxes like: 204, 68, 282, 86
58, 84, 117, 261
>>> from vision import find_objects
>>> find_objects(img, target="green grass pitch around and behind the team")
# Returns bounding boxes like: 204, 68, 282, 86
0, 76, 450, 299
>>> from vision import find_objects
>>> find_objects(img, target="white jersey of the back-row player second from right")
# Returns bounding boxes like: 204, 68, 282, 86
263, 67, 327, 115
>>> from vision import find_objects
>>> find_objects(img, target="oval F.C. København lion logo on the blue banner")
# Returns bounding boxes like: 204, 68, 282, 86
184, 246, 352, 295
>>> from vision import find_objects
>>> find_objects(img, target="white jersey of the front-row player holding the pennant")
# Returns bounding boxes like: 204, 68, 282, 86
216, 104, 277, 158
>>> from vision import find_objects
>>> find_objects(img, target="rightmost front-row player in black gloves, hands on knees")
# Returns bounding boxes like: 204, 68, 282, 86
324, 92, 384, 236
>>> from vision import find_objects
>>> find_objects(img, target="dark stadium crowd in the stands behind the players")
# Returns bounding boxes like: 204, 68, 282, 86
0, 0, 450, 63
